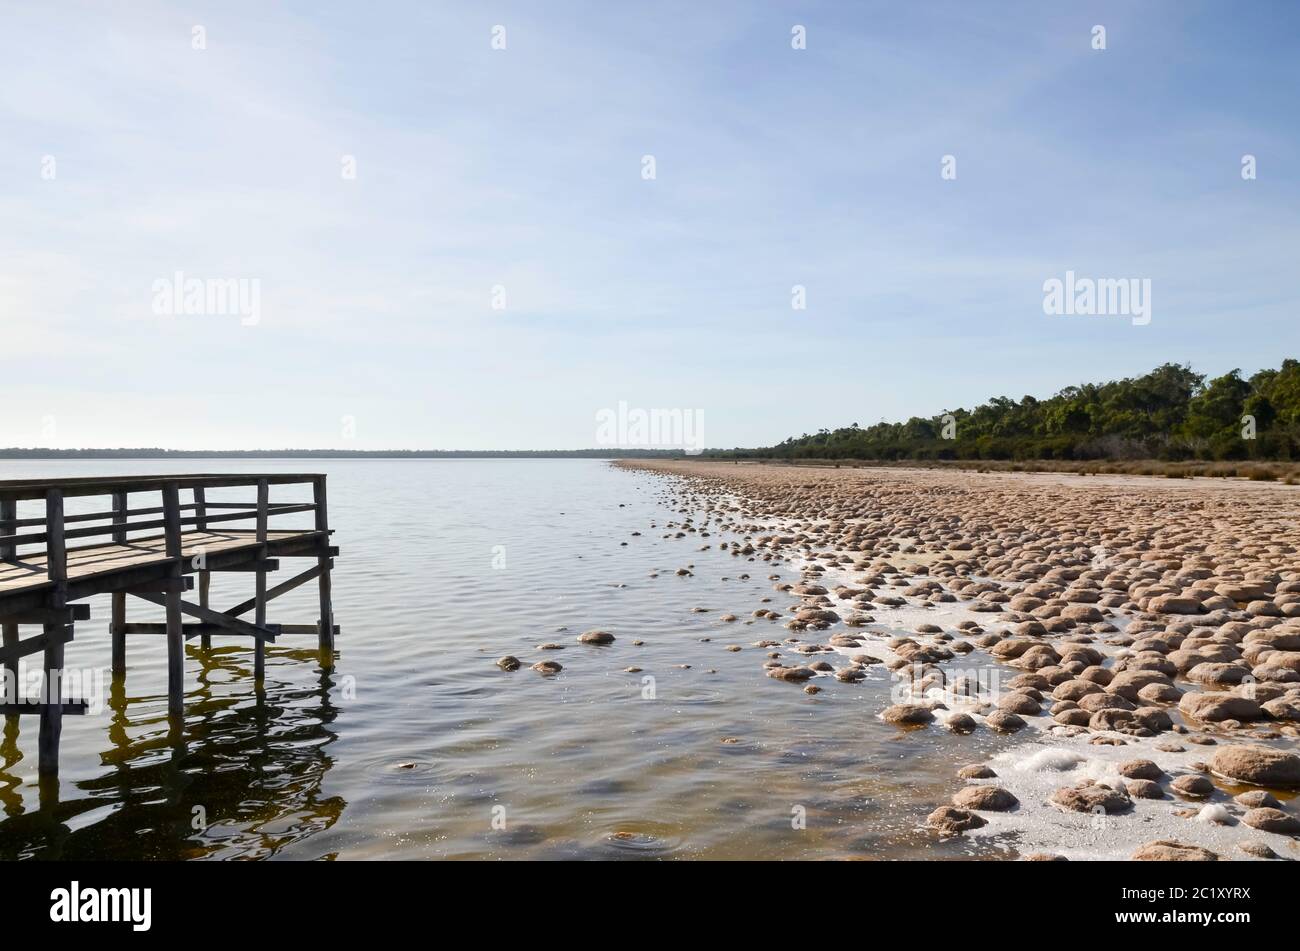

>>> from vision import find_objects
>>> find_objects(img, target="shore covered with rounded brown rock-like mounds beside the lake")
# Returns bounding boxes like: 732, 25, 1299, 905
618, 461, 1300, 859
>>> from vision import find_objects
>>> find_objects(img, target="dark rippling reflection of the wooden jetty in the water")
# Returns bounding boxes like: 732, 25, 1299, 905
0, 646, 347, 860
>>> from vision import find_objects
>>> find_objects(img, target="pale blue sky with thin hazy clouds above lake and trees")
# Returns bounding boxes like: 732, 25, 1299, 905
0, 0, 1300, 448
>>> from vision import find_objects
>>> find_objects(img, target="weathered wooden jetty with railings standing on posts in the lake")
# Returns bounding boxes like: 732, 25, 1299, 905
0, 473, 338, 777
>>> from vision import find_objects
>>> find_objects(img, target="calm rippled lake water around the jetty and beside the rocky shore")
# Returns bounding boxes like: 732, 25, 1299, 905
0, 460, 1011, 859
